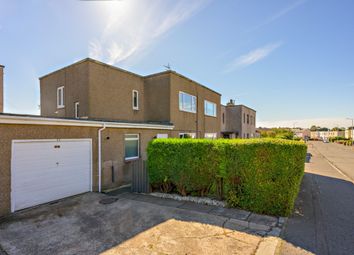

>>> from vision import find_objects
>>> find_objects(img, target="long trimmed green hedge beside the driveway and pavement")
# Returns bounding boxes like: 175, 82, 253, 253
147, 139, 307, 216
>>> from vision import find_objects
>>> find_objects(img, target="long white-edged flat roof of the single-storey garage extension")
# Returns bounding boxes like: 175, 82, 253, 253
0, 113, 174, 130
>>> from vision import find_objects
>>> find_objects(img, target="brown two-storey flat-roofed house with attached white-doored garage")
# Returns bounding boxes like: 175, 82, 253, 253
0, 59, 221, 216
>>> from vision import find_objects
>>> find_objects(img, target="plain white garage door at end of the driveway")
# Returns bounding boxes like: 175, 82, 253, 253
11, 139, 92, 212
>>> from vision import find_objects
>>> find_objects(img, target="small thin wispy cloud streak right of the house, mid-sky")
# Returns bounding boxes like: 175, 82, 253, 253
224, 42, 282, 73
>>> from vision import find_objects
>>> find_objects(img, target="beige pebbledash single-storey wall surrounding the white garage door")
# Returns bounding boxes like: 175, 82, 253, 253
0, 124, 170, 216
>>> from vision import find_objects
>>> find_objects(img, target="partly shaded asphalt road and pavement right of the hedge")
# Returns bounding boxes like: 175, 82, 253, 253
279, 142, 354, 254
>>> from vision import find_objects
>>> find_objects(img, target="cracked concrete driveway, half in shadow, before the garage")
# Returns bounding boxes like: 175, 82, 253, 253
0, 193, 262, 255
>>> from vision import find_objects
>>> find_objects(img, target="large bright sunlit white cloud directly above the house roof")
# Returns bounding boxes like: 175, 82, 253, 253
89, 0, 210, 64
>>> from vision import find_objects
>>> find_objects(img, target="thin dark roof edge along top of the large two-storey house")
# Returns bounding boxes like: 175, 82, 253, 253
39, 58, 221, 96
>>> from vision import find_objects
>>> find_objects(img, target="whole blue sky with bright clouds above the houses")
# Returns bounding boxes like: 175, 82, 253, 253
0, 0, 354, 127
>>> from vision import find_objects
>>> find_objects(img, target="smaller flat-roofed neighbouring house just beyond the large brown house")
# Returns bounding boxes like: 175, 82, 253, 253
221, 100, 258, 138
